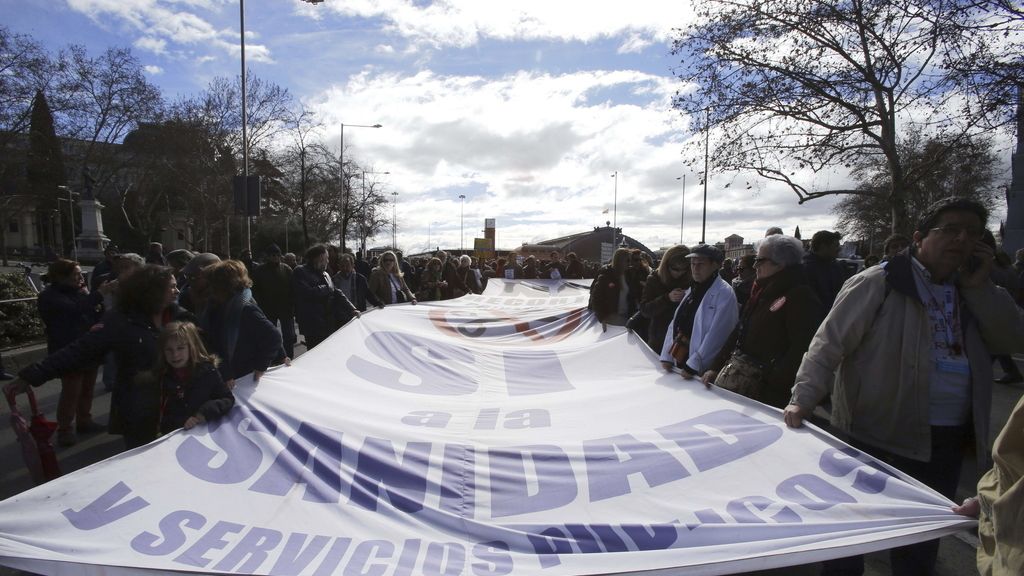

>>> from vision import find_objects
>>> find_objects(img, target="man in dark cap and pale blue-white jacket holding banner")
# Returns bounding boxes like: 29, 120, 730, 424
662, 244, 739, 378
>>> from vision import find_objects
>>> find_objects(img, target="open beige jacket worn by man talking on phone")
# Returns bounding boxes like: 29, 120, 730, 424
792, 255, 1024, 463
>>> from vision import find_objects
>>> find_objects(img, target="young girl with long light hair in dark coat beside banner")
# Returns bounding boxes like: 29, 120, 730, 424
155, 322, 234, 435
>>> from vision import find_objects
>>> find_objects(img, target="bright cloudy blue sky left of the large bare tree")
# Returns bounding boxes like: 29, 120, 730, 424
0, 0, 901, 251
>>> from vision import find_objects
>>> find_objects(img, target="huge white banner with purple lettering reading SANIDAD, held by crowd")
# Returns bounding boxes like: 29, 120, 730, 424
0, 279, 972, 576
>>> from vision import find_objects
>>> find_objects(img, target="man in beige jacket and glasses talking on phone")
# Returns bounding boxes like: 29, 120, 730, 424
784, 198, 1024, 574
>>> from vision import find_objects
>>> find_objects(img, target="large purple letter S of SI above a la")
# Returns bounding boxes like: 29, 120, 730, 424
346, 332, 478, 396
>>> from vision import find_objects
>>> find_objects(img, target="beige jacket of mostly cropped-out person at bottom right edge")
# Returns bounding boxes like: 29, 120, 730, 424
978, 398, 1024, 576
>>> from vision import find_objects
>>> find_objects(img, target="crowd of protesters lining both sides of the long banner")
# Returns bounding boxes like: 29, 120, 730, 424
2, 193, 1024, 574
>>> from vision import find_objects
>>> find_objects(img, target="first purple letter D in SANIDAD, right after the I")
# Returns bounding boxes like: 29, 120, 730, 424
487, 445, 579, 518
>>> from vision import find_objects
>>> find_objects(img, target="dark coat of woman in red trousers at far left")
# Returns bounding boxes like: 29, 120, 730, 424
37, 284, 103, 354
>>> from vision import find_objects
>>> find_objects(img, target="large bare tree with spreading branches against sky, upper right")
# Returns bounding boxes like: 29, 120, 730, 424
673, 0, 1015, 231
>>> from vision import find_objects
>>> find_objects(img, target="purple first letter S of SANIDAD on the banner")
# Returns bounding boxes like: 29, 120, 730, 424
175, 406, 276, 484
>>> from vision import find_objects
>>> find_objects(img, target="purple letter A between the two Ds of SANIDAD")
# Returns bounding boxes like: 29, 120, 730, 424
583, 435, 690, 502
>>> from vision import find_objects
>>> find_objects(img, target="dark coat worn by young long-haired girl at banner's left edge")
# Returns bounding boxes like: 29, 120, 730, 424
160, 363, 234, 434
